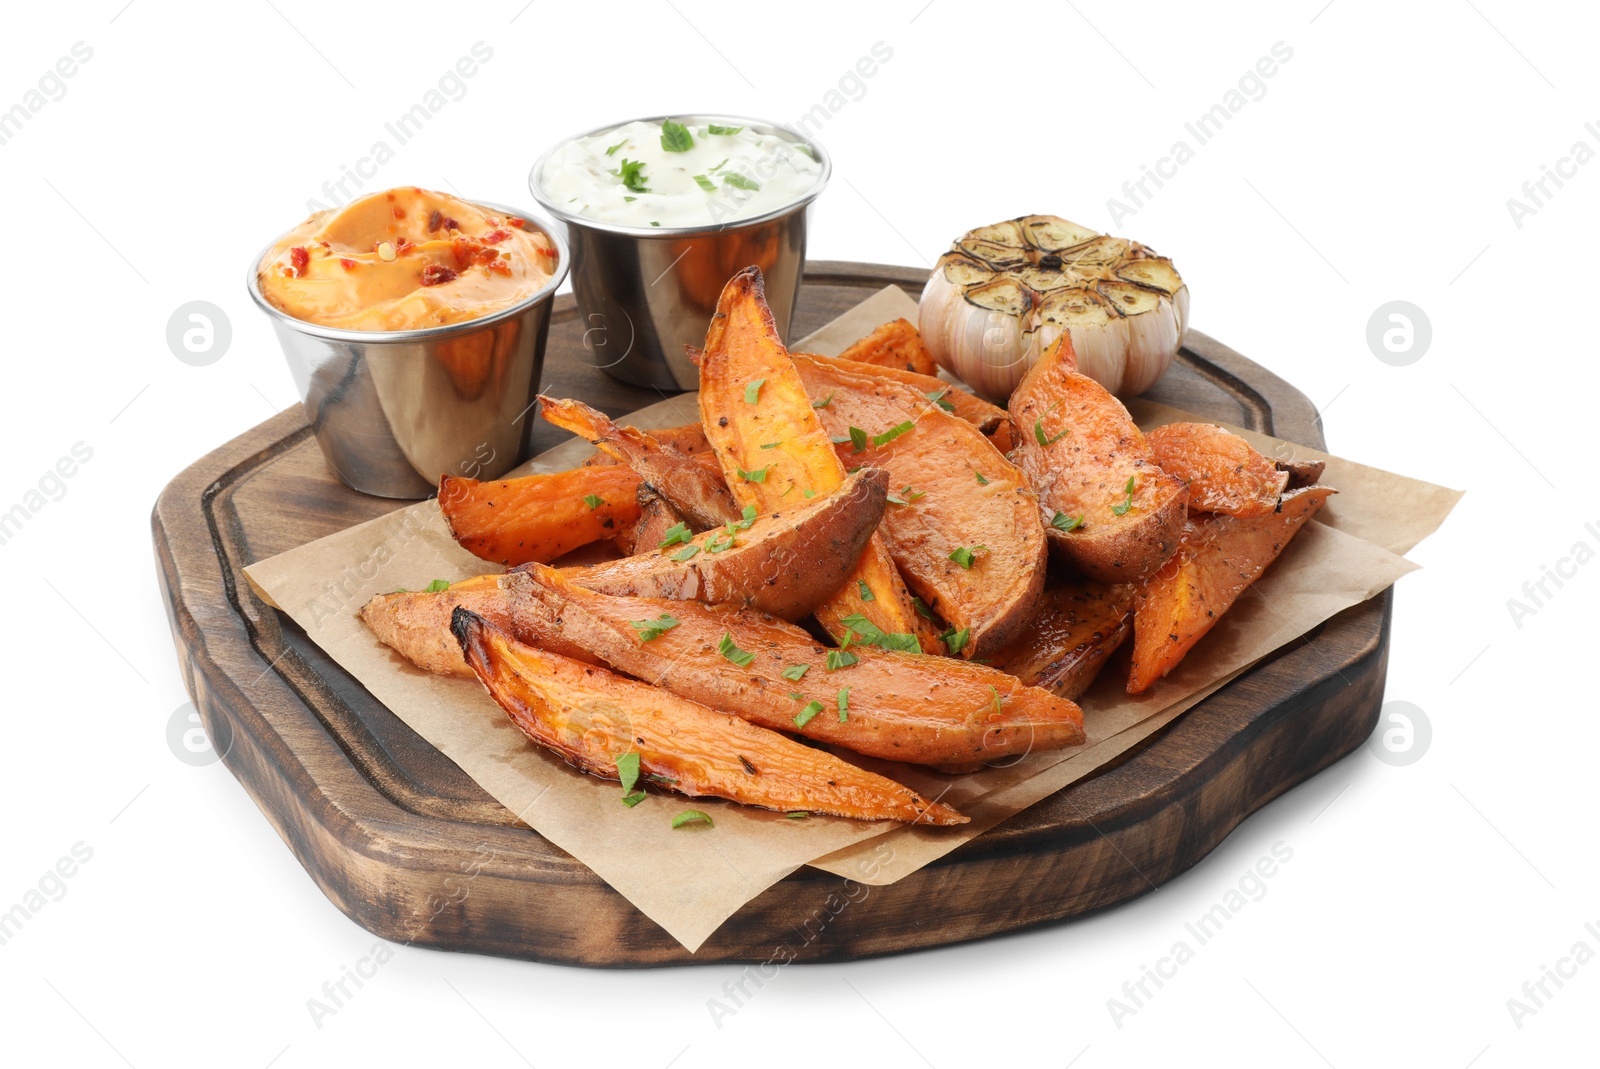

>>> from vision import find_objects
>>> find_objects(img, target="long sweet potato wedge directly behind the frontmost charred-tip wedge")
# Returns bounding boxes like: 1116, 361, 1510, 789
507, 565, 1083, 767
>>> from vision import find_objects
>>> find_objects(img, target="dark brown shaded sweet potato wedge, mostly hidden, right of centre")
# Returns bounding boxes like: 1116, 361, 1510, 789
994, 579, 1133, 701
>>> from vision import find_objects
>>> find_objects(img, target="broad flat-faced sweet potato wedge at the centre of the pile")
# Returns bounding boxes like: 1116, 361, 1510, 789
795, 360, 1048, 658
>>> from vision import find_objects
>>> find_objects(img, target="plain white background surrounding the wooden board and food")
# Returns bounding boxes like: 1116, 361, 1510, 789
0, 0, 1600, 1069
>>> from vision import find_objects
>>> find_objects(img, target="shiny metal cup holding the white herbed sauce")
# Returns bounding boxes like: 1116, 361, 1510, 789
528, 115, 832, 390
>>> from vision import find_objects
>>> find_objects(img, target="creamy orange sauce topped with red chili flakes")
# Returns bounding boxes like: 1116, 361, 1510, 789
259, 187, 557, 331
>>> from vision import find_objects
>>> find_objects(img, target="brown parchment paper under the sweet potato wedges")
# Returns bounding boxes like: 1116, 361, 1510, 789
246, 286, 1459, 952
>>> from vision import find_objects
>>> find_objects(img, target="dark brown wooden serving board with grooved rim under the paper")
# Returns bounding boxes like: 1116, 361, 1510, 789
152, 262, 1392, 965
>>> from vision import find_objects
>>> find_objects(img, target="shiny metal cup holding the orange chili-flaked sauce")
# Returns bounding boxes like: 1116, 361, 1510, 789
246, 202, 570, 498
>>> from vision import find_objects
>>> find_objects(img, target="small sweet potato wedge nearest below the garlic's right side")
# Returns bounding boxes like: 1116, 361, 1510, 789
1146, 422, 1290, 517
